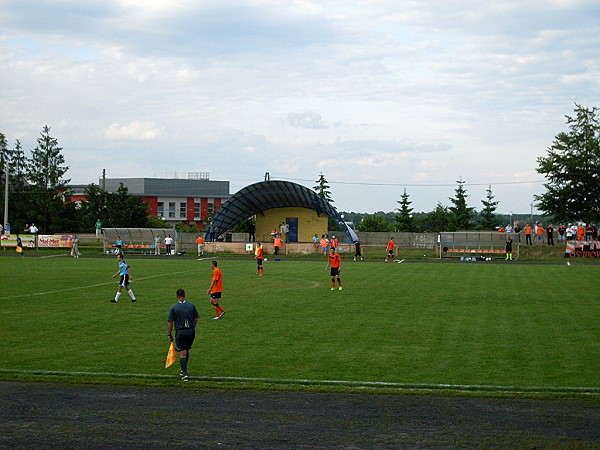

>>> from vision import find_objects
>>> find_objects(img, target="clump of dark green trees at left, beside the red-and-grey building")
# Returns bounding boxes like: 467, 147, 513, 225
0, 126, 156, 234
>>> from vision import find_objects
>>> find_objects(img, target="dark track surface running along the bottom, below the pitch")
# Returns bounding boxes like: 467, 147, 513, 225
0, 382, 600, 449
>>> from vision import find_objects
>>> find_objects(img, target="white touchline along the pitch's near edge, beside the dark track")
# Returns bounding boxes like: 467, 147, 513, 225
0, 369, 600, 396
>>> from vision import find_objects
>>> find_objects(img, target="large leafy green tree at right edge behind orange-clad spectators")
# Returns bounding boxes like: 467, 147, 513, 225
535, 103, 600, 222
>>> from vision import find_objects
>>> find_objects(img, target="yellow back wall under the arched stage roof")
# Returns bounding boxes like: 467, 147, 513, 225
256, 208, 328, 242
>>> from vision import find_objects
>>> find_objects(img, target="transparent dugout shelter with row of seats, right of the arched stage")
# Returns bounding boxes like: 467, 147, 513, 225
438, 231, 520, 259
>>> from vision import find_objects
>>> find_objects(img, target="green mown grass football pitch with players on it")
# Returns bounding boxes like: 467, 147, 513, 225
0, 253, 600, 395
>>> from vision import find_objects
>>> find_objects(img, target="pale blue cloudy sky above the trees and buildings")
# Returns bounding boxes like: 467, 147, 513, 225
0, 0, 600, 213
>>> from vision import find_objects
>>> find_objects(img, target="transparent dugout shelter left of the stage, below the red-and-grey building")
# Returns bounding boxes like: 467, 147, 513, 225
102, 228, 179, 254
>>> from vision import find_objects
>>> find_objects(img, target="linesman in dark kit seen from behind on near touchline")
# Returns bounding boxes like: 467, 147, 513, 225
167, 289, 200, 381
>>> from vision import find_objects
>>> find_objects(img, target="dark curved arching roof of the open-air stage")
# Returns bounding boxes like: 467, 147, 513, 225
205, 180, 358, 242
